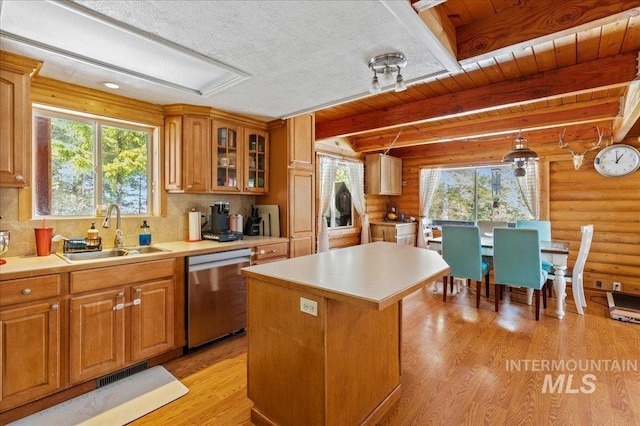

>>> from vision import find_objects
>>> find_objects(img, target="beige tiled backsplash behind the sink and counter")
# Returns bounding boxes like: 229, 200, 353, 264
0, 188, 259, 257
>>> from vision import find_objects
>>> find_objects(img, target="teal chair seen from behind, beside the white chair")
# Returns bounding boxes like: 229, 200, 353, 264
493, 228, 547, 321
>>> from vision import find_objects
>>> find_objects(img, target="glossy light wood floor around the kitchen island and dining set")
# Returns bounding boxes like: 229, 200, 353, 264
133, 287, 640, 425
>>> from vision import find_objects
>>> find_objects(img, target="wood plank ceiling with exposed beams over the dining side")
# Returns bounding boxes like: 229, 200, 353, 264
316, 0, 640, 152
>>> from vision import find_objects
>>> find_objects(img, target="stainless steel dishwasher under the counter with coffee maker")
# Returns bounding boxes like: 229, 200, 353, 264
187, 249, 251, 348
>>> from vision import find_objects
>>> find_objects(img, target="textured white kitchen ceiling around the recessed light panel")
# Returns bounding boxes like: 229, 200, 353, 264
0, 0, 446, 119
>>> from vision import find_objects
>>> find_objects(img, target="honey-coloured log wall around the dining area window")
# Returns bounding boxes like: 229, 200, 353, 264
367, 130, 640, 294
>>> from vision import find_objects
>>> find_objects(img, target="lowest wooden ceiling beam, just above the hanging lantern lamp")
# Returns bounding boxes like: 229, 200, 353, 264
351, 99, 618, 152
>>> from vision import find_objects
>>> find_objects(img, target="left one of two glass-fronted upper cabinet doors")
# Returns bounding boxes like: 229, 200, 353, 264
213, 123, 242, 191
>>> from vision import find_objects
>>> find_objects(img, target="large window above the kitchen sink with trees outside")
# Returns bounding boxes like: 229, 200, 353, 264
33, 109, 154, 216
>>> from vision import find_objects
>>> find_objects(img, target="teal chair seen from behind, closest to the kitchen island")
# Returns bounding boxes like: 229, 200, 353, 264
442, 226, 491, 308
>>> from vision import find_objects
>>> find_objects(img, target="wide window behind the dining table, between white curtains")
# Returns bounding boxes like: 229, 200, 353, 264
429, 165, 532, 224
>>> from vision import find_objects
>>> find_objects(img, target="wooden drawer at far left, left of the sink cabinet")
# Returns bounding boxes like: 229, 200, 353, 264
0, 275, 62, 306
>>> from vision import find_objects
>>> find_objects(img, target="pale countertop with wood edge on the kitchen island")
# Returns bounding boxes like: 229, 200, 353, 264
242, 242, 449, 310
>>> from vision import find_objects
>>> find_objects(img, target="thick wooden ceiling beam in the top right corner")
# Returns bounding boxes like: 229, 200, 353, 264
456, 0, 640, 65
